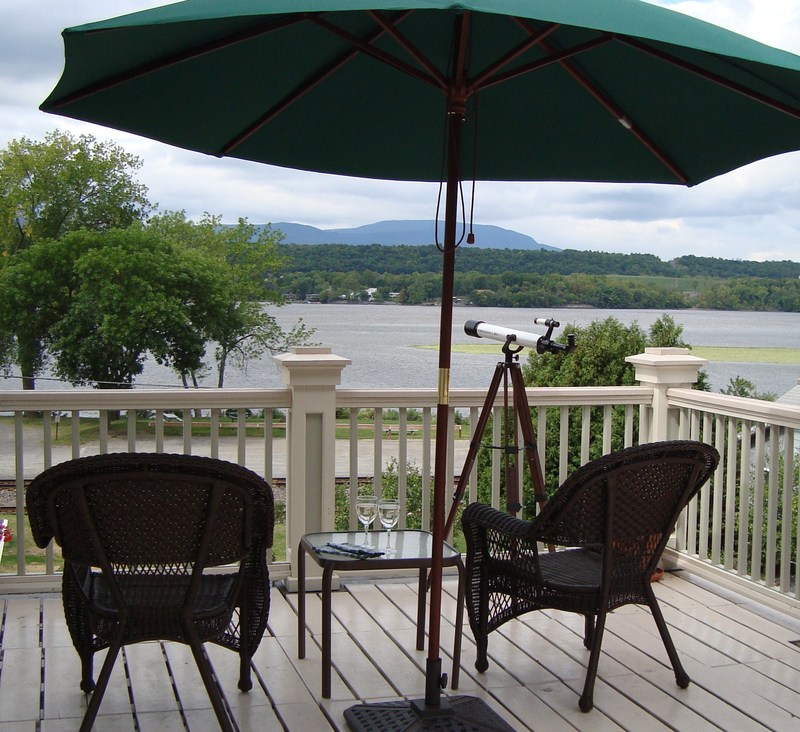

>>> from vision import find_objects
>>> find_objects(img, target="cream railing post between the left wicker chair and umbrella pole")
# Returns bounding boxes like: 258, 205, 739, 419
274, 346, 352, 578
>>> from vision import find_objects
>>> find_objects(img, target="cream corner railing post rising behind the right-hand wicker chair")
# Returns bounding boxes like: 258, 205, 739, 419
625, 348, 708, 442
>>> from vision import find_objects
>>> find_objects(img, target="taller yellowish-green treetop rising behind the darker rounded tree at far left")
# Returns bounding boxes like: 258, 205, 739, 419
0, 130, 150, 256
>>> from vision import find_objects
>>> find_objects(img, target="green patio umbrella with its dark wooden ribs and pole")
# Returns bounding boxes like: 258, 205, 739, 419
42, 0, 800, 729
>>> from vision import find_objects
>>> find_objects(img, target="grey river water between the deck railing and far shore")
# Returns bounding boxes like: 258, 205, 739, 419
0, 303, 800, 396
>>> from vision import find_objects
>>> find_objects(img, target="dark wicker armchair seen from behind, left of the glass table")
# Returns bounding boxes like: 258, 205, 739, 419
26, 453, 274, 730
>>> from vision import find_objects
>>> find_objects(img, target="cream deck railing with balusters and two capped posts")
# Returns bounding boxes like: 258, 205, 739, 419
0, 349, 800, 608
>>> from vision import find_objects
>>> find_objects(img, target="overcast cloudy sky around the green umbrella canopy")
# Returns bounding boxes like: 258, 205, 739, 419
0, 0, 800, 261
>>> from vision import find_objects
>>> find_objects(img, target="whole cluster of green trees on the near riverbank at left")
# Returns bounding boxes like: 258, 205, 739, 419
0, 131, 313, 389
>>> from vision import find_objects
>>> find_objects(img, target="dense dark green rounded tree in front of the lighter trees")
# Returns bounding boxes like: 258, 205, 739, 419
43, 228, 226, 388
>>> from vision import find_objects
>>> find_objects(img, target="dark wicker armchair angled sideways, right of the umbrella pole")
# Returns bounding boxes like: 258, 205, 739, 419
462, 441, 719, 712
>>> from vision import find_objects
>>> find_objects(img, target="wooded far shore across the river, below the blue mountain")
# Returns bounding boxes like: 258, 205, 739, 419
278, 244, 800, 312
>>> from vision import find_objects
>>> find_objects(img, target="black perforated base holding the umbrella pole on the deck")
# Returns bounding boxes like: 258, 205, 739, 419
344, 696, 514, 732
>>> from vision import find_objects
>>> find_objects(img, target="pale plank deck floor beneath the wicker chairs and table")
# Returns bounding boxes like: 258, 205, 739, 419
0, 574, 800, 732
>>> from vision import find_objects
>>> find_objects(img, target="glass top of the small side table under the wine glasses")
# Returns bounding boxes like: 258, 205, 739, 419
303, 529, 460, 562
